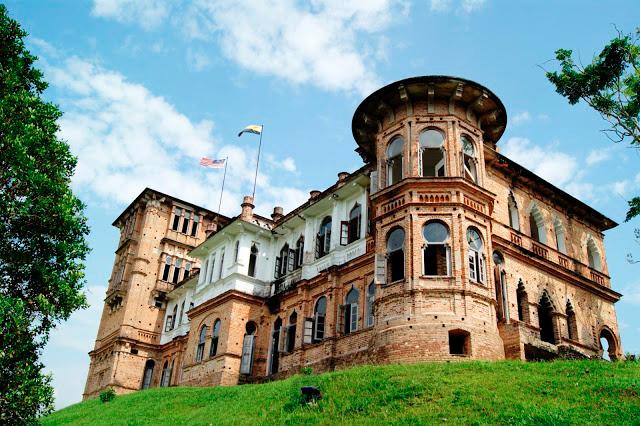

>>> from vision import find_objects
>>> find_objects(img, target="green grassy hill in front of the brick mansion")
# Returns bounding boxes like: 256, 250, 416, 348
43, 361, 640, 426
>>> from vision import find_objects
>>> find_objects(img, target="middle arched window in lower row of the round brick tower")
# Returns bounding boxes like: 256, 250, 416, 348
422, 220, 451, 276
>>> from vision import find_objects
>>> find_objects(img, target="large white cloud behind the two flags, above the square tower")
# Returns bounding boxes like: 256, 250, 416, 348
46, 57, 306, 215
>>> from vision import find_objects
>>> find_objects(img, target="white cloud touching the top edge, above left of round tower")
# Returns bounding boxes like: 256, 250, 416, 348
93, 0, 407, 93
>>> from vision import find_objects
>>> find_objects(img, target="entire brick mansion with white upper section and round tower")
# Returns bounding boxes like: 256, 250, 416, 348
84, 76, 622, 399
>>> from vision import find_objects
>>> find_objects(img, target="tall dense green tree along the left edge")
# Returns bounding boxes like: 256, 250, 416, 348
0, 4, 89, 424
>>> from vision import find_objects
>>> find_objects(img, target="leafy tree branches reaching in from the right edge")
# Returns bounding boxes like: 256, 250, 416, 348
546, 28, 640, 222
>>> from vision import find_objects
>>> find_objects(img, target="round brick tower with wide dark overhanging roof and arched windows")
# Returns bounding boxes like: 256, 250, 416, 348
352, 76, 507, 362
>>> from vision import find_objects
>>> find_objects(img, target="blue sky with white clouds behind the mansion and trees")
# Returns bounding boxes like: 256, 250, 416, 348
7, 0, 640, 407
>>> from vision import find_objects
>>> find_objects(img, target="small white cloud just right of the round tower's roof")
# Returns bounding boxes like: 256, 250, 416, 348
501, 137, 578, 187
